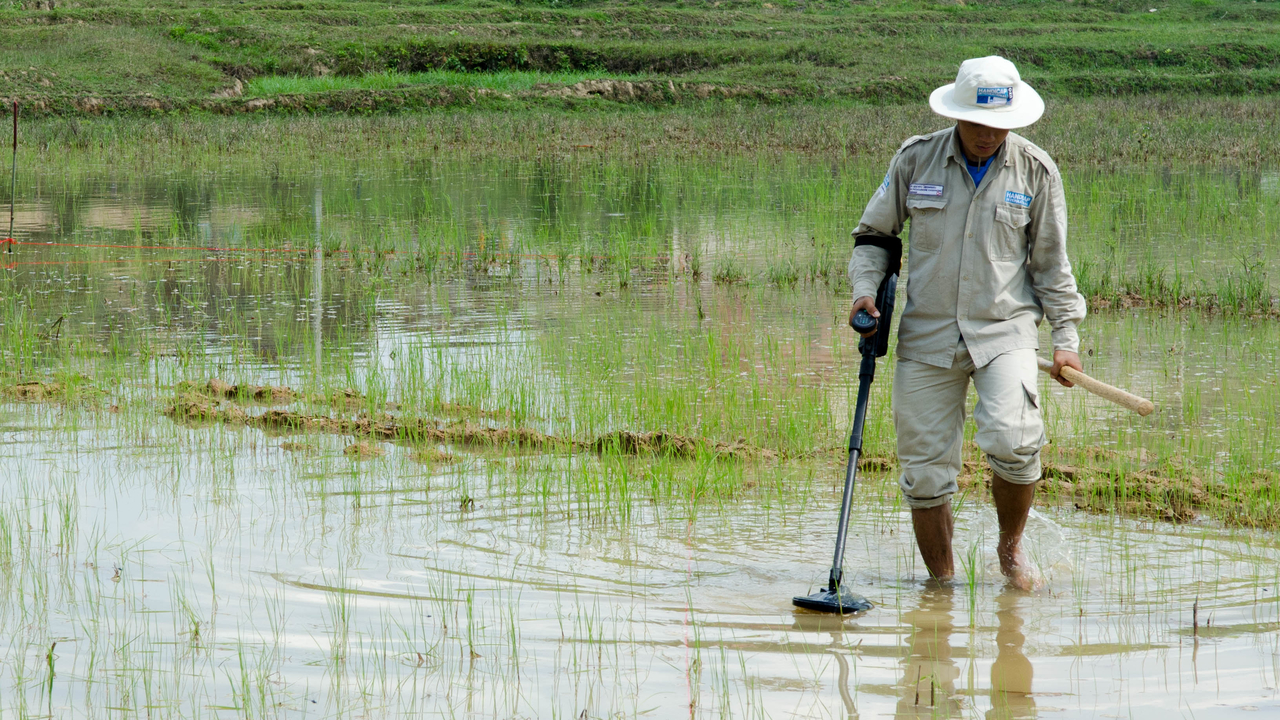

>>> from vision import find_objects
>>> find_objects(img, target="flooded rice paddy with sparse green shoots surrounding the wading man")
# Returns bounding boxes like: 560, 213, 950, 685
0, 159, 1280, 720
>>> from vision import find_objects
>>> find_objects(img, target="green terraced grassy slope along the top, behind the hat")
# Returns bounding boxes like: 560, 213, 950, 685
0, 0, 1280, 114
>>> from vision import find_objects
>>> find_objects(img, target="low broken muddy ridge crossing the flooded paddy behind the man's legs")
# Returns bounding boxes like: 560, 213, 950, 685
0, 379, 1280, 528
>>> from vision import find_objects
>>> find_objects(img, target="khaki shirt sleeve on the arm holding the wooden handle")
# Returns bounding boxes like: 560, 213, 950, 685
1027, 170, 1085, 352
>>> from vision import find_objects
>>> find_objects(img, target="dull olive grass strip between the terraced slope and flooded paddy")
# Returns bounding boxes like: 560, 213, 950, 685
18, 92, 1280, 166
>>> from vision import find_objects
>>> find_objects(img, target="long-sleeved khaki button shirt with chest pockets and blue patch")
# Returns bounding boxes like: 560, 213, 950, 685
849, 128, 1084, 368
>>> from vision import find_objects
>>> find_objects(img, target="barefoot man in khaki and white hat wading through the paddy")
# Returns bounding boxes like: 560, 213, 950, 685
849, 56, 1084, 589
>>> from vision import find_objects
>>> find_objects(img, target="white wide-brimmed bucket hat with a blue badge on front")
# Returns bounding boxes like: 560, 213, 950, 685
929, 55, 1044, 129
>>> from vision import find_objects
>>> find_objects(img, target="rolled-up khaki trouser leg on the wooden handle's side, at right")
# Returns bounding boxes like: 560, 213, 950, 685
973, 350, 1044, 484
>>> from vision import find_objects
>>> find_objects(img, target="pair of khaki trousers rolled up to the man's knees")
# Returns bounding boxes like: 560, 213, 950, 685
893, 340, 1046, 509
